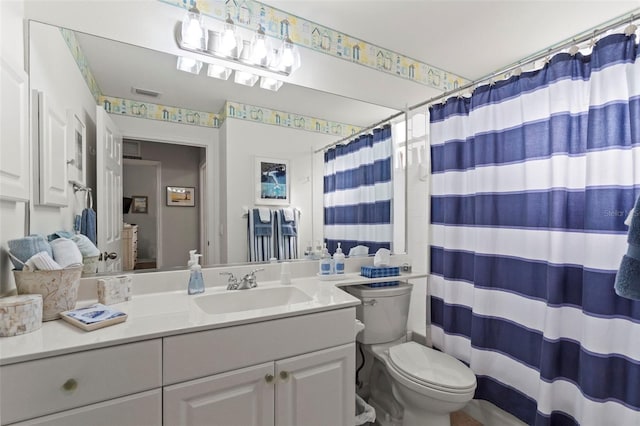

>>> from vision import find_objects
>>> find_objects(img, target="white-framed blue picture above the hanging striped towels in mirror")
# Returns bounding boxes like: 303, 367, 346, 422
254, 157, 291, 205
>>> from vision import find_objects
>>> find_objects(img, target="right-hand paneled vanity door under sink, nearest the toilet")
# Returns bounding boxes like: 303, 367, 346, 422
275, 343, 355, 426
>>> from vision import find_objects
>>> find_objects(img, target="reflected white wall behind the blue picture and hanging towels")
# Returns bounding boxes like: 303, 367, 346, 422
222, 118, 336, 262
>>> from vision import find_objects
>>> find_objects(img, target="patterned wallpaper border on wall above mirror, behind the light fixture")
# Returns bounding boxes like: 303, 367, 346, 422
158, 0, 469, 91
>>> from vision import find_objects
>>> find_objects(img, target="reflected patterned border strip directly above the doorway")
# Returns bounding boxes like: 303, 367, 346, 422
99, 95, 223, 129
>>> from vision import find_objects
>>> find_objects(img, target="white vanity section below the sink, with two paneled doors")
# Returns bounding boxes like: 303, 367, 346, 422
163, 308, 355, 426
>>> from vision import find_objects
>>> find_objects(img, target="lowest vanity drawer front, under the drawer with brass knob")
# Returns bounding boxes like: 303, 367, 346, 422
8, 389, 162, 426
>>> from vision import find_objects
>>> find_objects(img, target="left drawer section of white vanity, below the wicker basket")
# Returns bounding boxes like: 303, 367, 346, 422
0, 339, 162, 426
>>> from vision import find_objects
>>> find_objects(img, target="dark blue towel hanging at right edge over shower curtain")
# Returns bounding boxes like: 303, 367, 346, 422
614, 197, 640, 300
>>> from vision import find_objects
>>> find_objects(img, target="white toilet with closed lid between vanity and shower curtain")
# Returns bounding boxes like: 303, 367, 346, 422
345, 283, 476, 426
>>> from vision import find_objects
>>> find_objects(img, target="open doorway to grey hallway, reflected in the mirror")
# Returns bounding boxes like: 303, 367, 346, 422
122, 139, 207, 269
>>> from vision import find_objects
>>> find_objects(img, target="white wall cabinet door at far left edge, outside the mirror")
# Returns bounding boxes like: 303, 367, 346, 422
0, 58, 29, 201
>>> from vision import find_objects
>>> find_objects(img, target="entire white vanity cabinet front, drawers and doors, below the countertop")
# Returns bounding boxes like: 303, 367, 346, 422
0, 305, 355, 426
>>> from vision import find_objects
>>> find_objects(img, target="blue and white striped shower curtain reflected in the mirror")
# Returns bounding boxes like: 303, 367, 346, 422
324, 126, 393, 253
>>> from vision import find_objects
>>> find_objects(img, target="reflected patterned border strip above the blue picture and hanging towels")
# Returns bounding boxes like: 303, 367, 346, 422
224, 101, 361, 137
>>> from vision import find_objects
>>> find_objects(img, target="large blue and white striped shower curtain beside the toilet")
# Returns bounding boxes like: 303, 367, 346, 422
429, 34, 640, 426
